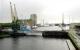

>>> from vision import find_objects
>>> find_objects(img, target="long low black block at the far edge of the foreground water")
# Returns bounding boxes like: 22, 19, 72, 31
42, 31, 68, 38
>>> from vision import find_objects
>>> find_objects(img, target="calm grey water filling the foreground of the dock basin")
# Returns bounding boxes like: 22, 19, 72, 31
0, 37, 68, 50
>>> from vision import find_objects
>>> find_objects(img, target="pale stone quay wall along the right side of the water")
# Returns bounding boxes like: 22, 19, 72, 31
68, 23, 80, 50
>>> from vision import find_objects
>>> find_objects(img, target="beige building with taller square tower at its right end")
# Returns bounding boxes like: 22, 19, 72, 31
18, 14, 37, 28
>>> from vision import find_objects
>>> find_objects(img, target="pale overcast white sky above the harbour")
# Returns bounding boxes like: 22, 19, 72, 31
0, 0, 80, 23
